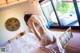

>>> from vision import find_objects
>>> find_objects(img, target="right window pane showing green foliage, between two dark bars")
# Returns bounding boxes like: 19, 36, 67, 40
52, 0, 80, 26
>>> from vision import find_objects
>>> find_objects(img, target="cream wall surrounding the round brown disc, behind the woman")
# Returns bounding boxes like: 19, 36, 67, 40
0, 0, 43, 46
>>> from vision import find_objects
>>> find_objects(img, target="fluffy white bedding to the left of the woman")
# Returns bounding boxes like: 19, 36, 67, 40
6, 33, 40, 53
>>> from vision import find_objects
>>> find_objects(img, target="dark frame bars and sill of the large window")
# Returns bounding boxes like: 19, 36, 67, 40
39, 0, 80, 29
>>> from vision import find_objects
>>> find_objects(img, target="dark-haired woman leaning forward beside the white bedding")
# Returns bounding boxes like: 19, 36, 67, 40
24, 14, 63, 53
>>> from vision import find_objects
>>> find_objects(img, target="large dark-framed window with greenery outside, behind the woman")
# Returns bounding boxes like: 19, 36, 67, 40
40, 0, 80, 27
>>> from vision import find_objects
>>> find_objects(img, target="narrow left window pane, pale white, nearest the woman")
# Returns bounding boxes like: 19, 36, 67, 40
40, 0, 59, 26
